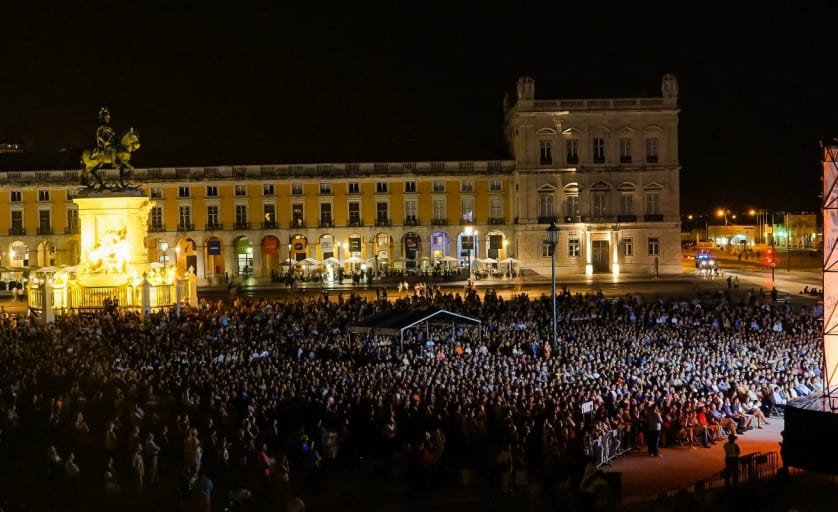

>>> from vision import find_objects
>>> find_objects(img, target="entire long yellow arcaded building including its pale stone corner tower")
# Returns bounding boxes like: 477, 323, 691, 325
0, 75, 680, 284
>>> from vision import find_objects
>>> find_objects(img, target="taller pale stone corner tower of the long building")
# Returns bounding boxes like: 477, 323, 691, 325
506, 74, 681, 275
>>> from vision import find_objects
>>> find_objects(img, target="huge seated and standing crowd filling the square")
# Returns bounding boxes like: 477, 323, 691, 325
0, 289, 823, 511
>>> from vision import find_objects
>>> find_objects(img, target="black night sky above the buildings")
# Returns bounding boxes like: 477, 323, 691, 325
0, 1, 838, 213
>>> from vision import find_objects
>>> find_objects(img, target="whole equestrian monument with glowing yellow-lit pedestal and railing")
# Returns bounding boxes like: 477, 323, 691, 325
28, 108, 197, 322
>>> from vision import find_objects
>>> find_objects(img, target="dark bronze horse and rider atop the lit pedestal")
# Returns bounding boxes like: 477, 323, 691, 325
81, 107, 140, 190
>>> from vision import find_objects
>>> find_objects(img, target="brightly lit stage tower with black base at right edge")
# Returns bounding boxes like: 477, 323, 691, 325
783, 139, 838, 474
